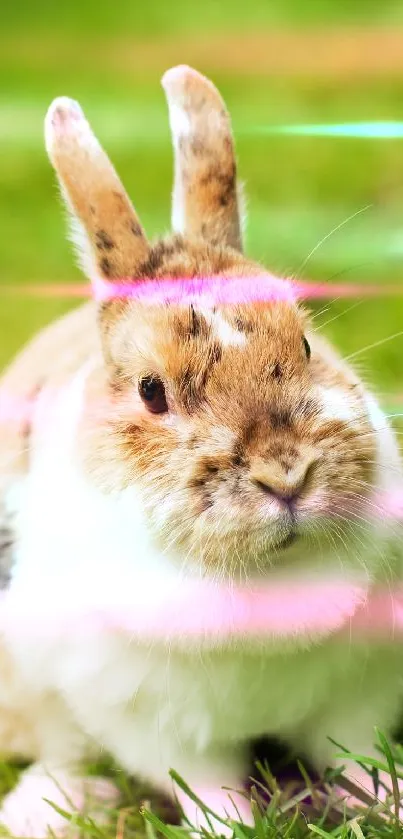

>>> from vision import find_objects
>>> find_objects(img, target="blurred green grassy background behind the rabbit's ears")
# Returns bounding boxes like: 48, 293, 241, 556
0, 0, 403, 410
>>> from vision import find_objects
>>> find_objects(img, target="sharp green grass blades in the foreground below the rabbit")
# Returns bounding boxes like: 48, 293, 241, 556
2, 731, 403, 839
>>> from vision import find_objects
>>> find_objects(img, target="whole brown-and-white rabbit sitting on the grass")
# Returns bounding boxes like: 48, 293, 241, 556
0, 66, 403, 837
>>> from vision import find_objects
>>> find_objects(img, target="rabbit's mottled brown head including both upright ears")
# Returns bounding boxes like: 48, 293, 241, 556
46, 67, 392, 574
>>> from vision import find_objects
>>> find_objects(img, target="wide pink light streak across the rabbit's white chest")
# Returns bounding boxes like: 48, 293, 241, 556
0, 579, 403, 648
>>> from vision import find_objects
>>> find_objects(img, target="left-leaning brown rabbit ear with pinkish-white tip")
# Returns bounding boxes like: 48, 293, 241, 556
45, 97, 150, 282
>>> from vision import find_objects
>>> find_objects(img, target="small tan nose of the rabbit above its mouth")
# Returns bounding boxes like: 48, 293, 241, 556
250, 452, 318, 506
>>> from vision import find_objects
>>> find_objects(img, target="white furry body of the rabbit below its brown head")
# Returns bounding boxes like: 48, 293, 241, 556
4, 296, 402, 832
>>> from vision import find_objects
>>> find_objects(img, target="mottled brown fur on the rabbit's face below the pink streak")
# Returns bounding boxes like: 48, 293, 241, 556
81, 278, 375, 576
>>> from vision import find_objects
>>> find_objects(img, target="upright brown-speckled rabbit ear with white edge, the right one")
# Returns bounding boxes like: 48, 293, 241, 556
162, 66, 242, 251
